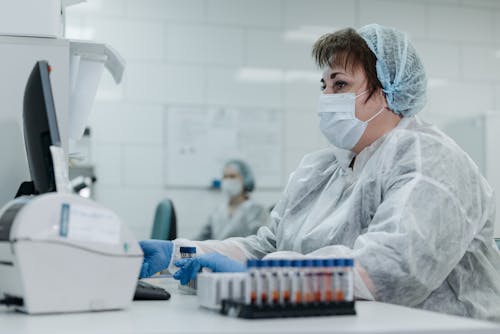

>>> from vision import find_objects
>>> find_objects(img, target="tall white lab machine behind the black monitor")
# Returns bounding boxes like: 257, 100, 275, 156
0, 0, 125, 205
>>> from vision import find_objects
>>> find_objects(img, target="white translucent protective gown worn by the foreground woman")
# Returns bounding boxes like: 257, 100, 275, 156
171, 117, 500, 320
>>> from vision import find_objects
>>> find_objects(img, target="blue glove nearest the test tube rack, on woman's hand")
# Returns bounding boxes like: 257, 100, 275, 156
174, 253, 247, 285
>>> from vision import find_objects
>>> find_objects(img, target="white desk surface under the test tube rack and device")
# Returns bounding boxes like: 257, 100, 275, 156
0, 279, 500, 334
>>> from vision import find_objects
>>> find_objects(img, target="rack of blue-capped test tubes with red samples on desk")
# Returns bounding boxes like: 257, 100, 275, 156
198, 259, 356, 319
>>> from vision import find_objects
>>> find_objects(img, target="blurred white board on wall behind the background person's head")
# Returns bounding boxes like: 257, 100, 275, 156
165, 108, 283, 187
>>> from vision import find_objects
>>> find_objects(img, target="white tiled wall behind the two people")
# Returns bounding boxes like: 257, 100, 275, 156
67, 0, 500, 238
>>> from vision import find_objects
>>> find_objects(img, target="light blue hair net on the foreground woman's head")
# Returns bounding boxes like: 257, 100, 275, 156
358, 24, 427, 117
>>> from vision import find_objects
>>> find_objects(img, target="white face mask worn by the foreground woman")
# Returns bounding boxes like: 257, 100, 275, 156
318, 90, 384, 150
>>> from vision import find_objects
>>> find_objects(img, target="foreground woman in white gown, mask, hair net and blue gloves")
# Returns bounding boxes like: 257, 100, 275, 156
141, 24, 500, 320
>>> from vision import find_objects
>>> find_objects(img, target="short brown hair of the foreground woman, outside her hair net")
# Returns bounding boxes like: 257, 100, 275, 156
312, 28, 382, 100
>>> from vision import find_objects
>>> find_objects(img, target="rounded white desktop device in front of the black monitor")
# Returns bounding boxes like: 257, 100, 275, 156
0, 193, 142, 314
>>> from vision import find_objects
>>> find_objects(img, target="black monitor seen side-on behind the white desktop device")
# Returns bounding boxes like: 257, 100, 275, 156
23, 61, 61, 193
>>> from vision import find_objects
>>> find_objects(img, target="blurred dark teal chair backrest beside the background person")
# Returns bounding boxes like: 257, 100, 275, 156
151, 198, 177, 240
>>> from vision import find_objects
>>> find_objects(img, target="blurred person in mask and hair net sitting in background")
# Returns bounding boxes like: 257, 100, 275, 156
194, 160, 270, 240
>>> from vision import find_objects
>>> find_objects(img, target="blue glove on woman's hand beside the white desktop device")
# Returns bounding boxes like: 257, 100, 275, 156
139, 240, 174, 278
